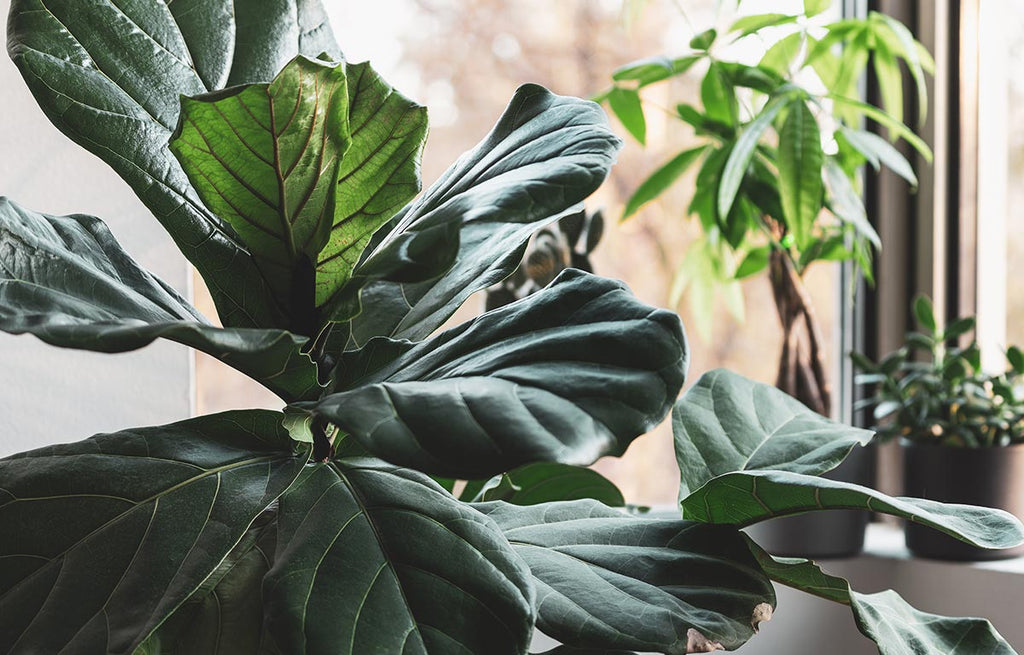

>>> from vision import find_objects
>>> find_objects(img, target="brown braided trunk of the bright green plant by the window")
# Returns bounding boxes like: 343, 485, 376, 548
769, 249, 831, 417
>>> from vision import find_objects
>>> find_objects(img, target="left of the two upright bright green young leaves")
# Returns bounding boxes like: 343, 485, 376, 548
170, 56, 351, 328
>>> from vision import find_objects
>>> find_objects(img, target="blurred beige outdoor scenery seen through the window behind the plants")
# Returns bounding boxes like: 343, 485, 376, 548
196, 0, 846, 505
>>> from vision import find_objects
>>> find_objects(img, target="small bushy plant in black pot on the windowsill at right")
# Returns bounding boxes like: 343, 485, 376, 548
853, 296, 1024, 560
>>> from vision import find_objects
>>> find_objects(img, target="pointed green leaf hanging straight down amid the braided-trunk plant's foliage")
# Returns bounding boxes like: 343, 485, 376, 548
777, 99, 823, 250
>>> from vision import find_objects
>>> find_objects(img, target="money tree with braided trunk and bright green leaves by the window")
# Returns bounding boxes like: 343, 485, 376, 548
599, 0, 934, 416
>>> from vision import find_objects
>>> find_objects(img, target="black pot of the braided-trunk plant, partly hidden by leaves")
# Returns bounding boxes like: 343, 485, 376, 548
745, 445, 876, 559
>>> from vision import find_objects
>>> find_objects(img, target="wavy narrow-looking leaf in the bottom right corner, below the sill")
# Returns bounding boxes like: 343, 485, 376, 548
750, 542, 1017, 655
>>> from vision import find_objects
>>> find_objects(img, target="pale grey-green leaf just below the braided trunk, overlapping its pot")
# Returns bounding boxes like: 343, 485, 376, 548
672, 369, 873, 497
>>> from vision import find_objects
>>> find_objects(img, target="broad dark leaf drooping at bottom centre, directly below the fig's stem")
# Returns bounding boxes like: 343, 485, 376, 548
263, 459, 535, 655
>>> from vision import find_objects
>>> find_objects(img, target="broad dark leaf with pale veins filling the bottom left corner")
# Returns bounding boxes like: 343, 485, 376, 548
0, 410, 306, 653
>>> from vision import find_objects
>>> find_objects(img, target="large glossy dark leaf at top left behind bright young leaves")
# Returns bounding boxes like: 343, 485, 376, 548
7, 0, 341, 328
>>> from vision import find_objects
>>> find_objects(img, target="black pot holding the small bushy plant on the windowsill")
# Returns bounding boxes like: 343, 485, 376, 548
901, 440, 1024, 561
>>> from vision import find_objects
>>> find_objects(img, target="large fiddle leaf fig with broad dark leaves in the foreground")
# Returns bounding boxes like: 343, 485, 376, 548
0, 0, 1024, 654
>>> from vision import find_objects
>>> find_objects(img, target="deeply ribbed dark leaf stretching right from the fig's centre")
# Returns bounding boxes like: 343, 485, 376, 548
311, 269, 688, 479
